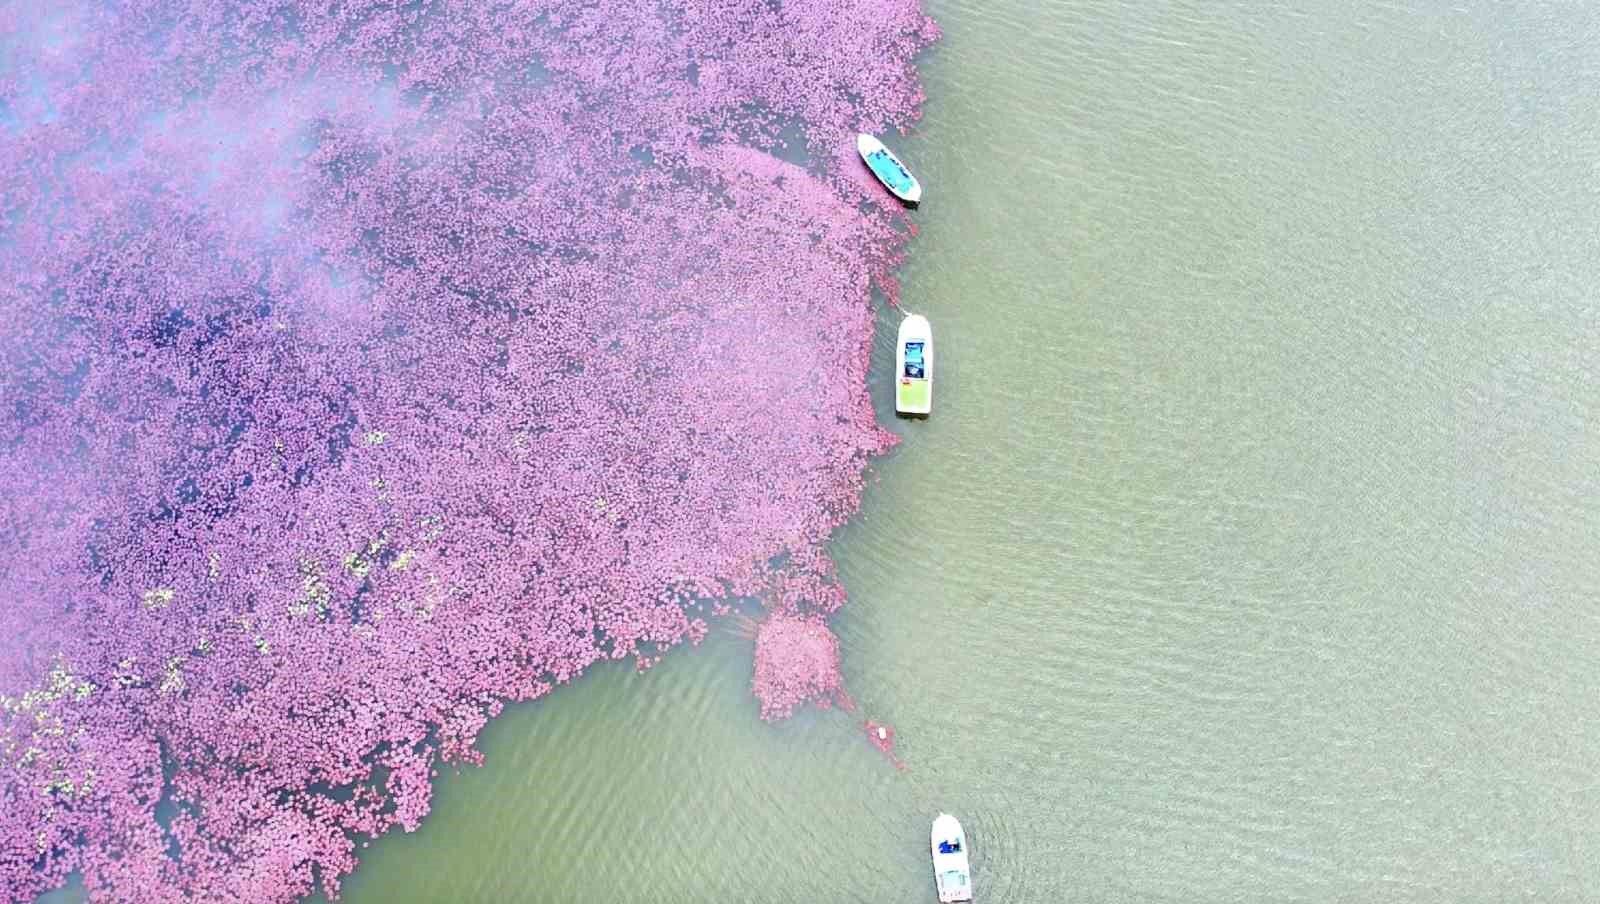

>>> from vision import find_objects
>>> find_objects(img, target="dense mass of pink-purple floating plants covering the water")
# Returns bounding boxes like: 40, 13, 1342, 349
0, 0, 936, 902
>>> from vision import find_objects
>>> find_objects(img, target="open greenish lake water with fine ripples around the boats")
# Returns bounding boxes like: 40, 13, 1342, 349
37, 0, 1600, 904
